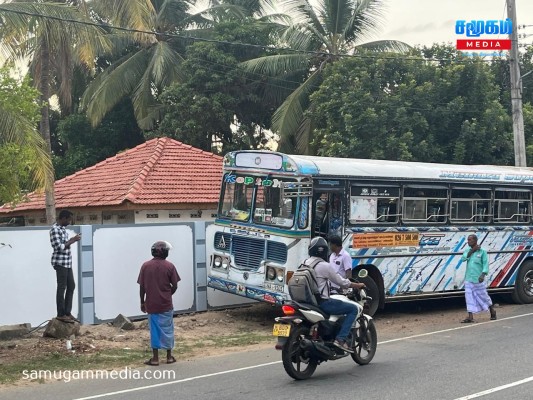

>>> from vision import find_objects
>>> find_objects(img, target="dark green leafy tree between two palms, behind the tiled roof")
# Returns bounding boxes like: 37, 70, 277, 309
149, 20, 275, 152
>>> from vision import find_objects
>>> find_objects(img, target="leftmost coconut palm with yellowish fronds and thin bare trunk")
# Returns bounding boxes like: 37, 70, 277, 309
0, 0, 109, 223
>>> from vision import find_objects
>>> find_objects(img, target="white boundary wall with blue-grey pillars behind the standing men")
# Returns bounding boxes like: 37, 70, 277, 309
0, 221, 250, 326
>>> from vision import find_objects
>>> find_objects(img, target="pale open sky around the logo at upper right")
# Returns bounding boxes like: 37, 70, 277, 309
371, 0, 533, 46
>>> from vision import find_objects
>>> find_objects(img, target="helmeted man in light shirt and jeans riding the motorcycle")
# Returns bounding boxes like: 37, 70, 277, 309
304, 237, 365, 353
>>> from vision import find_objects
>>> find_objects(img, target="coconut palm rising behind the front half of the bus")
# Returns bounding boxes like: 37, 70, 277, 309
242, 0, 409, 154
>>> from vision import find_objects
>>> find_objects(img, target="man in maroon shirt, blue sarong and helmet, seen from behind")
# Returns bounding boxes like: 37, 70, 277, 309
137, 241, 181, 365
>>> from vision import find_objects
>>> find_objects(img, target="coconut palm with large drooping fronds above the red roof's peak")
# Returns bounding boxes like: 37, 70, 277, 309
82, 0, 245, 130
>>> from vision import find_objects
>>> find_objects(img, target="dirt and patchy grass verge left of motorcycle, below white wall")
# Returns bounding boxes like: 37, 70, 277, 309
0, 304, 279, 385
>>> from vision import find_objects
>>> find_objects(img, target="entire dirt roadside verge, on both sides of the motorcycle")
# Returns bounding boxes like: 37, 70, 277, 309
0, 299, 532, 387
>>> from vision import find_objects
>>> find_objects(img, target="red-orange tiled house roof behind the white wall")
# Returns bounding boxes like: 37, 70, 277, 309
0, 138, 222, 213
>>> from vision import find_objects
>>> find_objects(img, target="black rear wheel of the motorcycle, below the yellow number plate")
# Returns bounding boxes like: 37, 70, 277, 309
281, 326, 317, 380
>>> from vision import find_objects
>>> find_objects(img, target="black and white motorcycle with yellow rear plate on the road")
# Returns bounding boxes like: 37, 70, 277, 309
272, 269, 377, 380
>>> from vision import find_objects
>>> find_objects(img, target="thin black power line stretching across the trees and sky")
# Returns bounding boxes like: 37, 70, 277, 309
0, 5, 498, 64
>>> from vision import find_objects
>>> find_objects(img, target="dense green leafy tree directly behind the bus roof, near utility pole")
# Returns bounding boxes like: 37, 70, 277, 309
310, 51, 513, 164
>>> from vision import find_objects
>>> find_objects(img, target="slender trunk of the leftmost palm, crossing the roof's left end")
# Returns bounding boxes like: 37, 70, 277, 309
39, 40, 56, 225
